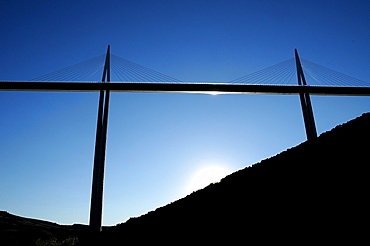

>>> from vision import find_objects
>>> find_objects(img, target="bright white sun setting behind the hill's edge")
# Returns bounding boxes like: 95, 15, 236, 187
186, 165, 231, 195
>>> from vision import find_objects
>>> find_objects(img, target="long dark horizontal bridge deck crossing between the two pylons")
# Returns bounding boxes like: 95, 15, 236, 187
0, 81, 370, 96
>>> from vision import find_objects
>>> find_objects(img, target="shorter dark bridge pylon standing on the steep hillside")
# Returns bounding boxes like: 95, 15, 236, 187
294, 49, 317, 140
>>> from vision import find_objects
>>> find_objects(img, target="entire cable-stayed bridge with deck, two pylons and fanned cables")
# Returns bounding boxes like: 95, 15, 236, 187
0, 45, 370, 232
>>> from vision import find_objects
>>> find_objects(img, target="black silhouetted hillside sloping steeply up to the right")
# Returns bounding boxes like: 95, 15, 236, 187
101, 113, 370, 245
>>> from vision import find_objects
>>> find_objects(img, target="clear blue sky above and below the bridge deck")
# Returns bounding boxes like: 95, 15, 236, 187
0, 0, 370, 225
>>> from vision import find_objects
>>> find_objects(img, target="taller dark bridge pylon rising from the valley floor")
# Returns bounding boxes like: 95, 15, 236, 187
89, 45, 110, 232
